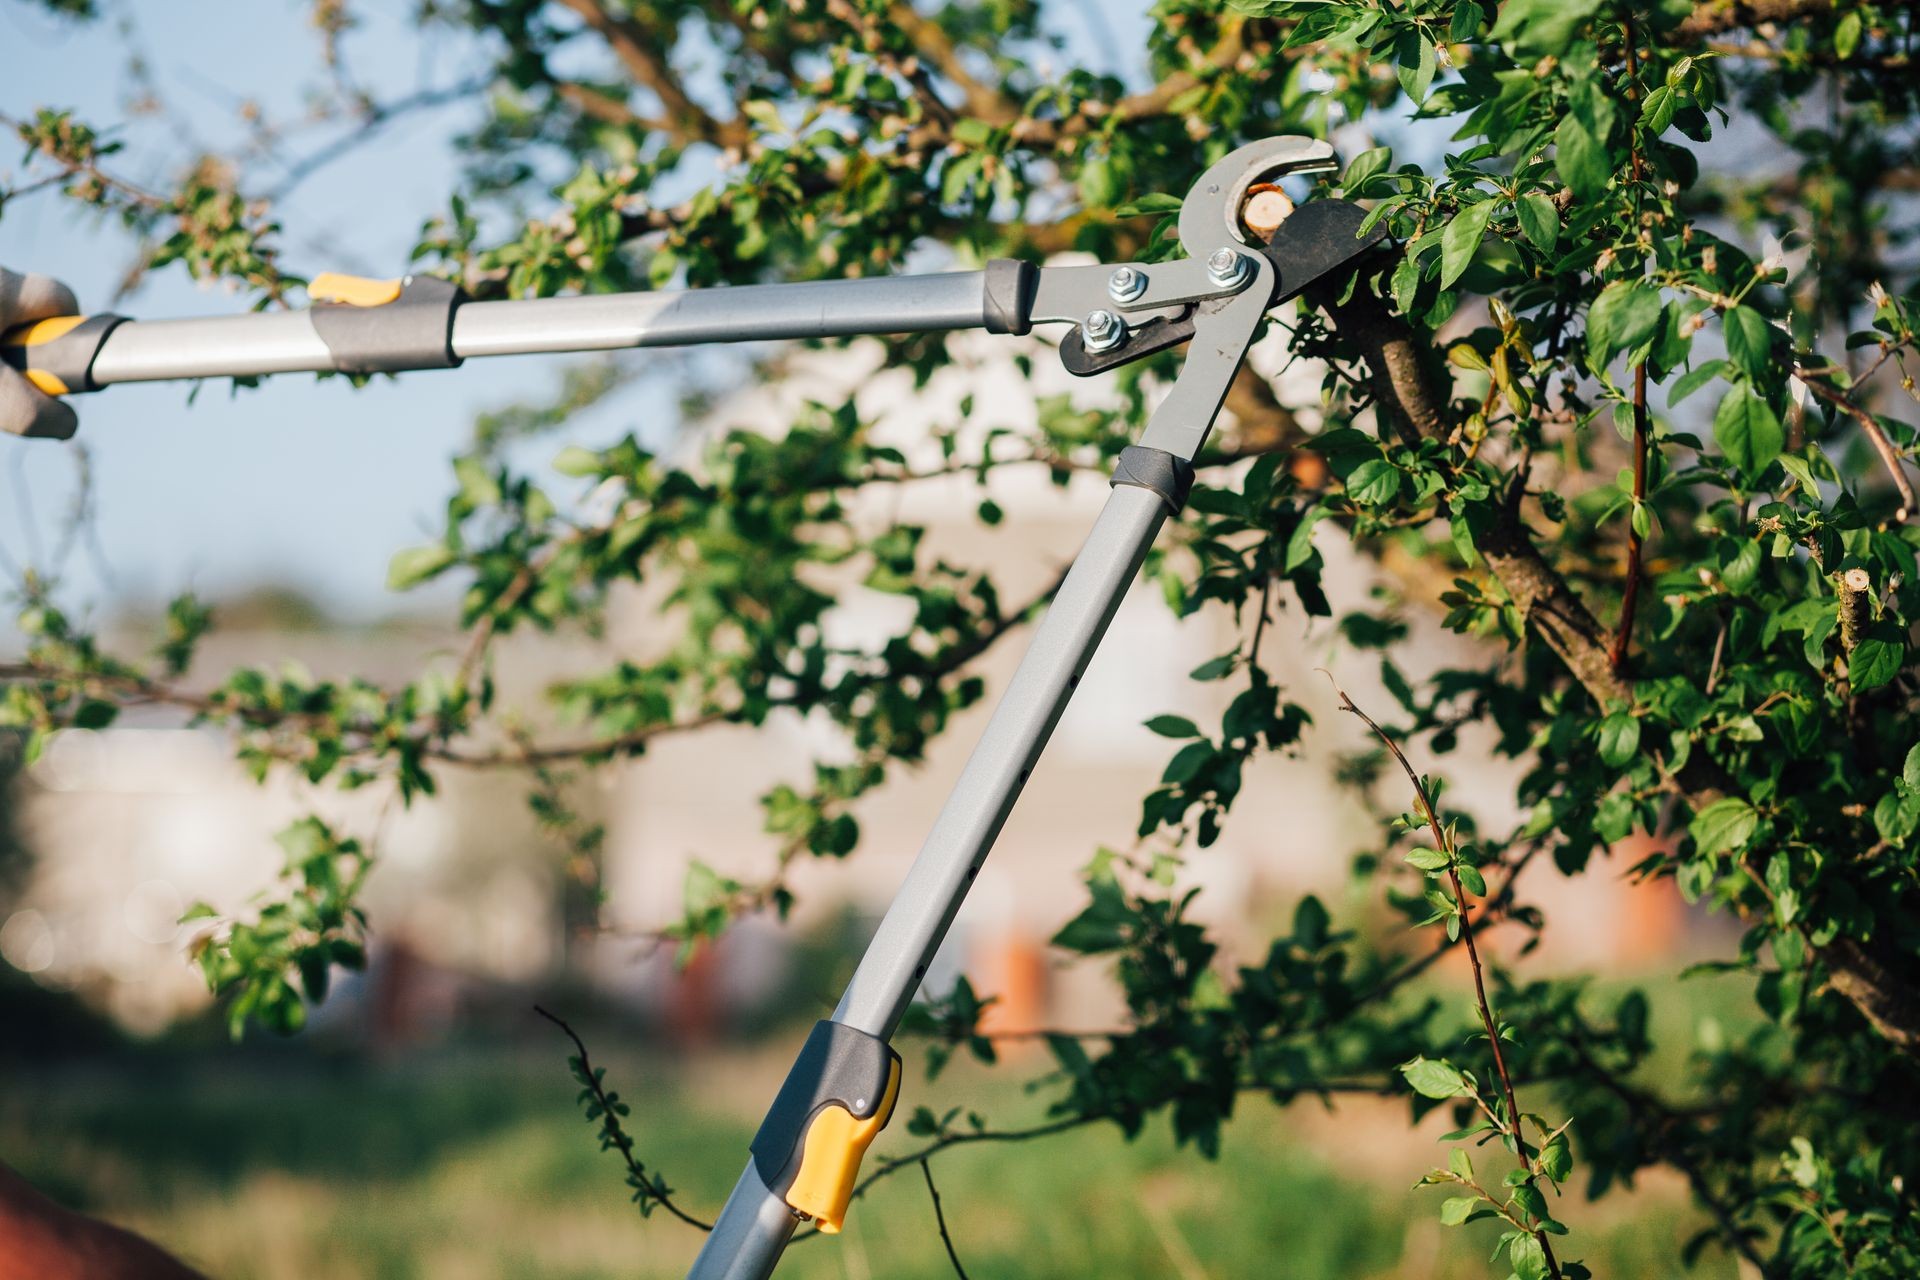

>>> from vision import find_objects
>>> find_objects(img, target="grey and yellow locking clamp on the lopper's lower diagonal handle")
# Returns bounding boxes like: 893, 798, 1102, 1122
751, 1021, 900, 1234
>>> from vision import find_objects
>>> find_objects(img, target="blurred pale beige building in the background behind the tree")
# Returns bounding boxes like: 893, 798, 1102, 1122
0, 318, 1680, 1036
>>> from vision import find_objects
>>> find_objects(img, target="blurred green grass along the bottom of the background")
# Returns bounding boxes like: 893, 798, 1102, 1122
0, 1046, 1734, 1280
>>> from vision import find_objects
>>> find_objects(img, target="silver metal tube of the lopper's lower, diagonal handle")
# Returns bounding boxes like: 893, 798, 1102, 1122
687, 482, 1169, 1280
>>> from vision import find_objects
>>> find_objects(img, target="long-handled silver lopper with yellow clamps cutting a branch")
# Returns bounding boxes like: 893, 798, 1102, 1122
0, 136, 1380, 1280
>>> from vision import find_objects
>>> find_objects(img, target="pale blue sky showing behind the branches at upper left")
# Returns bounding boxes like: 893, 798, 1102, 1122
0, 0, 1146, 618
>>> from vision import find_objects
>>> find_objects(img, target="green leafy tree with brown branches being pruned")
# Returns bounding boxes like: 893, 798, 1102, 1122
0, 0, 1920, 1280
